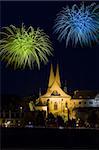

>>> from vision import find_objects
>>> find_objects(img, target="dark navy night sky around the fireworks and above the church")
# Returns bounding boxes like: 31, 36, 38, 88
1, 1, 99, 96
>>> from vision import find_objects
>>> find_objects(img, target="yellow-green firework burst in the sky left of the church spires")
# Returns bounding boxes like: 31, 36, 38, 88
0, 24, 53, 69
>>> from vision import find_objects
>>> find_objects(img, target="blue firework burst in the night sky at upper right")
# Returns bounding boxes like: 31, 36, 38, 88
54, 3, 99, 47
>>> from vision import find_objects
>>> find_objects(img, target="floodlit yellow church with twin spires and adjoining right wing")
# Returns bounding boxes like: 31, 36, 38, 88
29, 64, 99, 119
